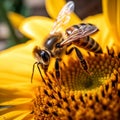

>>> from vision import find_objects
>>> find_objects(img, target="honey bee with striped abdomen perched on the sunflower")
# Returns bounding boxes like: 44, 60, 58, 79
31, 1, 102, 82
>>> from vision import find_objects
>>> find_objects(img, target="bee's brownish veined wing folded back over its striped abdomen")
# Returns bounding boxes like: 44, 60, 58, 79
60, 24, 98, 46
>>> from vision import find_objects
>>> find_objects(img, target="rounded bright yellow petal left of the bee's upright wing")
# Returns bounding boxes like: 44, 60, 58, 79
20, 16, 53, 47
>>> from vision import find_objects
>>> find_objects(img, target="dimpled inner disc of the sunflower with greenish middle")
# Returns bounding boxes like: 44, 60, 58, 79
61, 55, 119, 91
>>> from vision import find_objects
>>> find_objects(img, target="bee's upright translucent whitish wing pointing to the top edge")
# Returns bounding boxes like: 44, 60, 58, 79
50, 1, 74, 34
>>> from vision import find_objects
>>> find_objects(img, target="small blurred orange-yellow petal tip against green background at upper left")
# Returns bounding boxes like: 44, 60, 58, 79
8, 12, 25, 28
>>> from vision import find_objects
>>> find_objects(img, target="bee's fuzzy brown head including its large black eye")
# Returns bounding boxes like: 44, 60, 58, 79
33, 46, 50, 65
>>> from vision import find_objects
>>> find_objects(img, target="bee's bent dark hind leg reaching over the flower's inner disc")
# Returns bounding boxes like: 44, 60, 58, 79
66, 47, 89, 73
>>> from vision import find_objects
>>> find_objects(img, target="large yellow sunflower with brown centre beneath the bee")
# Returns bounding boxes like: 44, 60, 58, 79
0, 0, 120, 120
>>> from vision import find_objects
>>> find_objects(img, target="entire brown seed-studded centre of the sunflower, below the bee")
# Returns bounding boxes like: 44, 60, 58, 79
33, 48, 120, 120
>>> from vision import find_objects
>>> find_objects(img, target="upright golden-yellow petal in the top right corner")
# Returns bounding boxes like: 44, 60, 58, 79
102, 0, 120, 47
